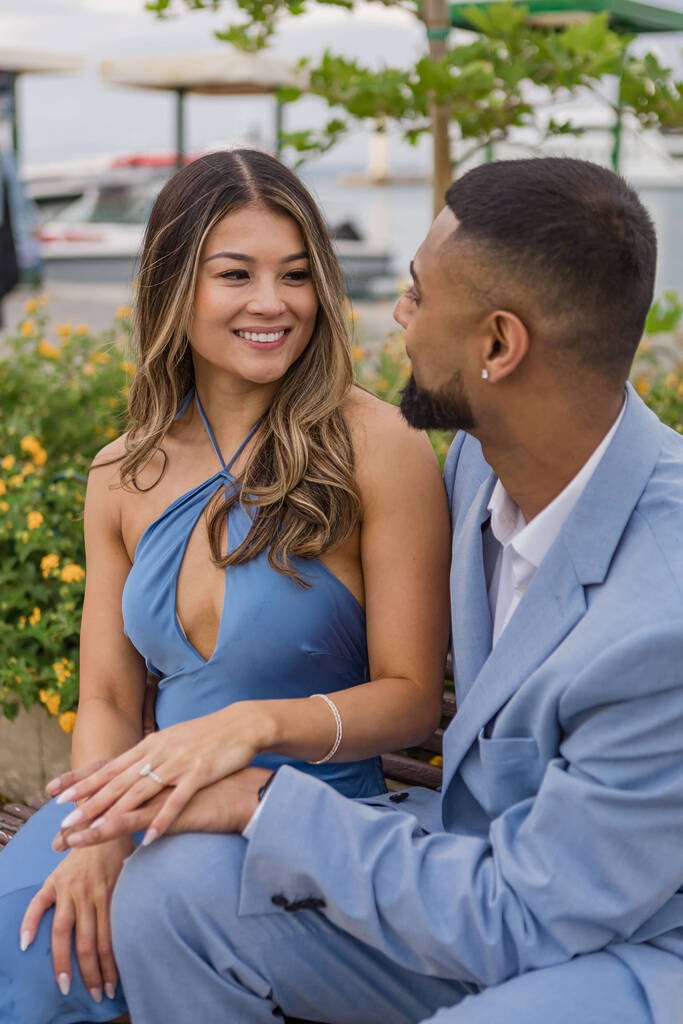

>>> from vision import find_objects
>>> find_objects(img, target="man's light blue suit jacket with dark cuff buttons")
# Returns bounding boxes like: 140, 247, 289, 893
241, 388, 683, 1022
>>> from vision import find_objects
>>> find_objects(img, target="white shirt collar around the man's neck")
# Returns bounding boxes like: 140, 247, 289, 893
488, 395, 628, 568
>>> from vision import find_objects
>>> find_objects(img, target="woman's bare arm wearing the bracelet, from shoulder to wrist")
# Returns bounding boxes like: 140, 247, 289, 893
255, 392, 451, 761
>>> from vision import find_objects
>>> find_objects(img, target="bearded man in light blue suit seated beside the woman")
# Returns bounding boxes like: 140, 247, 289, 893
66, 159, 683, 1024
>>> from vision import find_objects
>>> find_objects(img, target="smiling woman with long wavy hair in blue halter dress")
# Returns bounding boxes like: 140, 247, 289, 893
0, 151, 449, 1024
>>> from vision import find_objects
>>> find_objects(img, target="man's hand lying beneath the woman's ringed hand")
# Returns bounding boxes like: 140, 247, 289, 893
53, 767, 271, 850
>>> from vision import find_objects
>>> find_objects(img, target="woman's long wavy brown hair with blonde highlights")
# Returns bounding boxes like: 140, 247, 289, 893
121, 150, 360, 584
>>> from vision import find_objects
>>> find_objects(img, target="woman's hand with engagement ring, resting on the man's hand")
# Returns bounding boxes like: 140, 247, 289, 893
52, 700, 276, 850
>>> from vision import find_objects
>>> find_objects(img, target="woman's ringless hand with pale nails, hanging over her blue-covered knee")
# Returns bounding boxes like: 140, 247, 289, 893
20, 837, 134, 1002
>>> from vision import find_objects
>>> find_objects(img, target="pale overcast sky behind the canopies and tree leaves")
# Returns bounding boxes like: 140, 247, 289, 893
0, 0, 683, 167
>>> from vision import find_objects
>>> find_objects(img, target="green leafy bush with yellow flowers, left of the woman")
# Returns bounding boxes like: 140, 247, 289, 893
0, 300, 132, 732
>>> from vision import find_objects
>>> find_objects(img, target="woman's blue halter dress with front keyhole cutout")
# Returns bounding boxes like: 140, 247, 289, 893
0, 394, 385, 1024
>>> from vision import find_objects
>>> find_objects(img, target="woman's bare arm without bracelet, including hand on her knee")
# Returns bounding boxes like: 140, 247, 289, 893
20, 442, 144, 1002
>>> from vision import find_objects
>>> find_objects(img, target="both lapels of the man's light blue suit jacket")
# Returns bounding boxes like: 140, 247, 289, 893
442, 385, 663, 794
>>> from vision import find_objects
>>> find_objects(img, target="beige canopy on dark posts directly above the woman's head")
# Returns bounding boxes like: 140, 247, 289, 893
100, 47, 305, 167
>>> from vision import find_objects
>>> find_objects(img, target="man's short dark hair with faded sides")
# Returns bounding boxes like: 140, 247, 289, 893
445, 157, 656, 379
